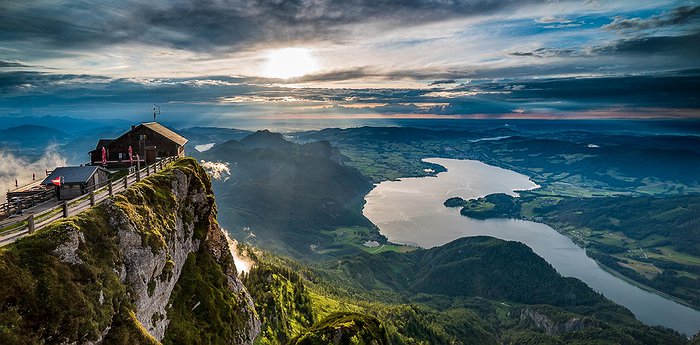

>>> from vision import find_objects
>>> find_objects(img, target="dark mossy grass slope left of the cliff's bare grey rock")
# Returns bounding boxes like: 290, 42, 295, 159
0, 207, 145, 344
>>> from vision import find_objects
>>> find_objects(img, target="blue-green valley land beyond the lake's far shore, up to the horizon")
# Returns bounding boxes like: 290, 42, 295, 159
300, 125, 700, 307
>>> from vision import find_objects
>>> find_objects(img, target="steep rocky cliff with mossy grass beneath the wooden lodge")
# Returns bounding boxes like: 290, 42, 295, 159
0, 159, 260, 344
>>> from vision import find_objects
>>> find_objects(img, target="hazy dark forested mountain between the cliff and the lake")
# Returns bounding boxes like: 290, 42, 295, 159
202, 131, 381, 257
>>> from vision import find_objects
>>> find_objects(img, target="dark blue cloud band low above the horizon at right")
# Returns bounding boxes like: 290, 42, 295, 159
294, 70, 700, 116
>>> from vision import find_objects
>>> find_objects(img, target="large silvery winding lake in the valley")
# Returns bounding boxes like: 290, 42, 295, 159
363, 158, 700, 336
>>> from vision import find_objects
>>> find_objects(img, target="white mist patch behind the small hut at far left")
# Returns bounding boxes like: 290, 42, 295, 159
0, 146, 67, 203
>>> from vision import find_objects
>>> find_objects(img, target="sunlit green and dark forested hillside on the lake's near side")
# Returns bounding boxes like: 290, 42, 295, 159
239, 237, 687, 344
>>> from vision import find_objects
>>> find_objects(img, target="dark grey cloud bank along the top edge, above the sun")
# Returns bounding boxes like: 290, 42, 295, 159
0, 0, 543, 50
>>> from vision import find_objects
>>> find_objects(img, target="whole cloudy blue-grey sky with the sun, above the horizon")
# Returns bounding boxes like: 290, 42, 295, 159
0, 0, 700, 126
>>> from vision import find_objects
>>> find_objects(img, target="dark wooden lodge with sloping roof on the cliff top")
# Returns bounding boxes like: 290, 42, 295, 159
90, 122, 187, 169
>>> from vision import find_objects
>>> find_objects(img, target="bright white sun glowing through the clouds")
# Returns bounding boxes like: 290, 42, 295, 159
262, 48, 319, 79
